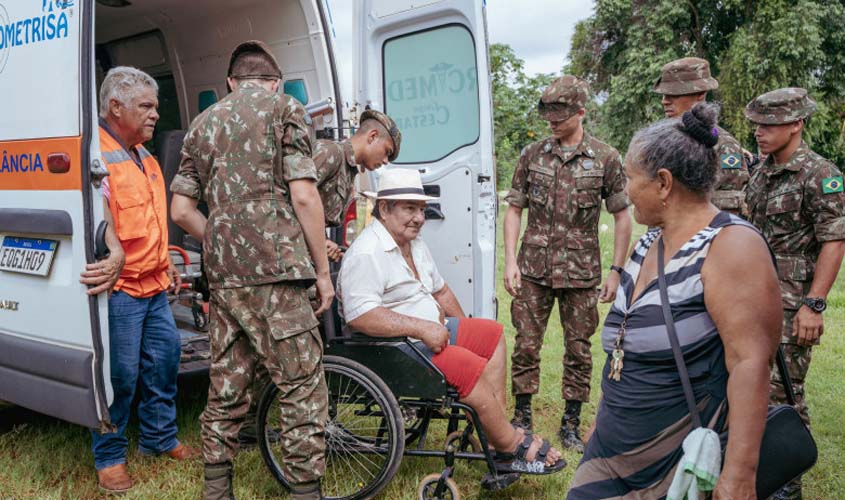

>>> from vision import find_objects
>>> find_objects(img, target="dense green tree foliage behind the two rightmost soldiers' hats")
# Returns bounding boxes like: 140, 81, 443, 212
566, 0, 845, 166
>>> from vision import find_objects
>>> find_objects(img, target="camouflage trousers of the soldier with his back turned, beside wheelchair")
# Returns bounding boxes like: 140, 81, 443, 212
200, 283, 328, 484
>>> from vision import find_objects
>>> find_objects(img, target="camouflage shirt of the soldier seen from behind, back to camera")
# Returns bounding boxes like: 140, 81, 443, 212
170, 82, 317, 288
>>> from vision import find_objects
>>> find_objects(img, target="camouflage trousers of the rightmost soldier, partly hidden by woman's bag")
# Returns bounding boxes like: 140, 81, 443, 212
769, 310, 813, 427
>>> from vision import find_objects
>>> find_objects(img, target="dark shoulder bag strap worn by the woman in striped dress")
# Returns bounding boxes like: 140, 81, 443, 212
657, 235, 795, 422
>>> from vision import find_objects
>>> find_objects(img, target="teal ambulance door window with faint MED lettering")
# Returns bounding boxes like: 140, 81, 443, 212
382, 24, 480, 163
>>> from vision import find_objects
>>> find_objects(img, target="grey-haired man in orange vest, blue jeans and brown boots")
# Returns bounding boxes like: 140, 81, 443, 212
89, 66, 199, 493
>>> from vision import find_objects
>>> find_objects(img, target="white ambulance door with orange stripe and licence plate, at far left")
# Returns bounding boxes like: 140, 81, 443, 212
0, 0, 111, 429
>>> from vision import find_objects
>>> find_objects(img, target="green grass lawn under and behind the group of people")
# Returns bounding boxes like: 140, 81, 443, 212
0, 206, 845, 500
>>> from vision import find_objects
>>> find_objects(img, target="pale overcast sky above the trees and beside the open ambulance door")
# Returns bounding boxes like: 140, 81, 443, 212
324, 0, 593, 105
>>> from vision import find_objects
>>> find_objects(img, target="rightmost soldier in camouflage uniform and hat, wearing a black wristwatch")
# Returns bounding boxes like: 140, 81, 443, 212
745, 88, 845, 499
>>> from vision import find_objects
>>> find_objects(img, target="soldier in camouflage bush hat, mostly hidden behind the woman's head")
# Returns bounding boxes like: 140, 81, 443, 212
654, 57, 748, 215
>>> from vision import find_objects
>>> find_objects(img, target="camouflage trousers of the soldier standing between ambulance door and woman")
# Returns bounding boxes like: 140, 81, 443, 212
511, 278, 599, 401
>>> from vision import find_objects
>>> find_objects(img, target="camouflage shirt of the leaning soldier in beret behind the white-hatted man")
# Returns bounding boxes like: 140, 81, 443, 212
313, 139, 358, 226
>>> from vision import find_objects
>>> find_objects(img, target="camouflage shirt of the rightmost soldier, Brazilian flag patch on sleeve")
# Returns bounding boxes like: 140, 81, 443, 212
745, 142, 845, 310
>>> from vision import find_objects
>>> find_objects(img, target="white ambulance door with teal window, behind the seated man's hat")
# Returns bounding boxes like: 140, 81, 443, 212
353, 0, 497, 318
